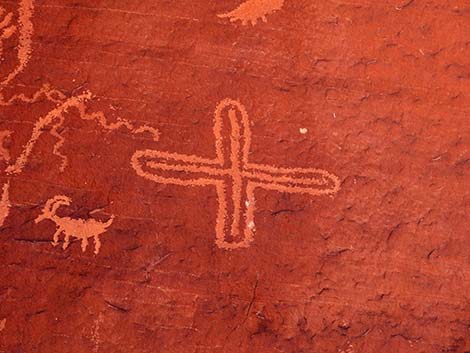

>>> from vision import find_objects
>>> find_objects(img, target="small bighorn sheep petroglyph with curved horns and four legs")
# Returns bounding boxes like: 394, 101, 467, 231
35, 195, 114, 254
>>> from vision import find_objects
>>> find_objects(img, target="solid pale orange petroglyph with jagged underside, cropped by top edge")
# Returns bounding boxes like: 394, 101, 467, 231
218, 0, 285, 26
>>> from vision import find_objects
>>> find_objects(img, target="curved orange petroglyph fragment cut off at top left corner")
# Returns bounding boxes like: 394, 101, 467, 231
0, 0, 34, 89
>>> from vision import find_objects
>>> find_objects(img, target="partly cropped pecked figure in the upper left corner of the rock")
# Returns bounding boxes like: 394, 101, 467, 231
0, 0, 34, 90
